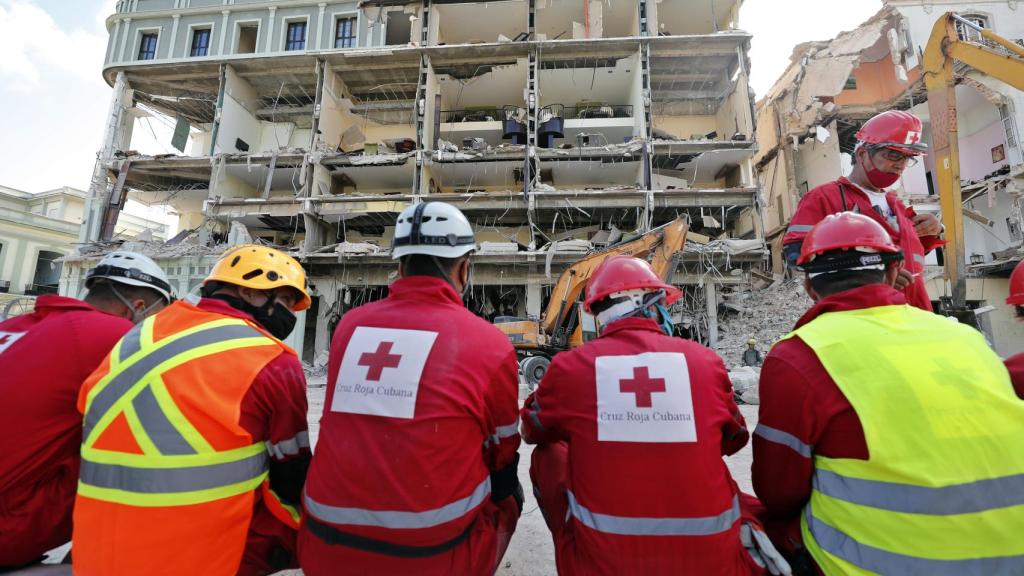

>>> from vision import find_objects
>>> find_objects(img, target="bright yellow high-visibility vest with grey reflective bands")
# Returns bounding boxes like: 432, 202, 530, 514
795, 305, 1024, 576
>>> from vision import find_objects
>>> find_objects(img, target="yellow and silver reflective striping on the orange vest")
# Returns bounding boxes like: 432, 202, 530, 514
79, 317, 275, 506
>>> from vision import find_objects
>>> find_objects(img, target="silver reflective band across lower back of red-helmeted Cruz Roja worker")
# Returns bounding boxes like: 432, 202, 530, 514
567, 490, 739, 536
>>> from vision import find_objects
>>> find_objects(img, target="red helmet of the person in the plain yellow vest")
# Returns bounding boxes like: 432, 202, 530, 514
797, 212, 900, 265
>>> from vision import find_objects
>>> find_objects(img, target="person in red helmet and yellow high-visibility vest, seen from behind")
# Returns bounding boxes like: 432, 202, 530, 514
753, 212, 1024, 575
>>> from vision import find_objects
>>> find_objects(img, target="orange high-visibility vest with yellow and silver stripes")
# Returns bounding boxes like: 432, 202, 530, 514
72, 301, 295, 576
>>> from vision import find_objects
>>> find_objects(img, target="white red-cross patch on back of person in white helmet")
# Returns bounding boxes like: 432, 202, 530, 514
331, 326, 437, 418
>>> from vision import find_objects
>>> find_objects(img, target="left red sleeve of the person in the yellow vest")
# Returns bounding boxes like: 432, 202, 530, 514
753, 342, 814, 518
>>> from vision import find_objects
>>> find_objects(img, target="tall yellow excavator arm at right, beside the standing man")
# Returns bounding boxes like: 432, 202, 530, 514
923, 12, 1024, 319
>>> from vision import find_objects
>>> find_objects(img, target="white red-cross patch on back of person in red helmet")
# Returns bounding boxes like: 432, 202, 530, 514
595, 353, 697, 443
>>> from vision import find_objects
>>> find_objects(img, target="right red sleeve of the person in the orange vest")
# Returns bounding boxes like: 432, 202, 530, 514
240, 354, 310, 461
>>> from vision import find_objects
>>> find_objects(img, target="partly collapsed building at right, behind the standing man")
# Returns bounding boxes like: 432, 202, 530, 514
754, 0, 1024, 356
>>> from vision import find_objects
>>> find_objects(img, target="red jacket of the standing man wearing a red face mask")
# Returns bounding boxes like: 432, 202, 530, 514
782, 178, 943, 312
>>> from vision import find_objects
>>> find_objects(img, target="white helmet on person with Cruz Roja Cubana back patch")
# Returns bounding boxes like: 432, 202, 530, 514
391, 202, 476, 259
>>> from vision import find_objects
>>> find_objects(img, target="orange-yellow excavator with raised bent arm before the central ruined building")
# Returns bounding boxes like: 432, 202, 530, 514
495, 218, 689, 388
